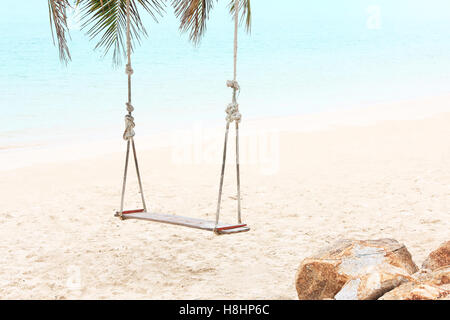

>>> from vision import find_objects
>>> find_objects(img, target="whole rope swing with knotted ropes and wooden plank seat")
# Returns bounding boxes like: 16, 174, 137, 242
115, 0, 250, 235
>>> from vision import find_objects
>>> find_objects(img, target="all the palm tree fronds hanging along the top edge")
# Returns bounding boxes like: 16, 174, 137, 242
48, 0, 251, 64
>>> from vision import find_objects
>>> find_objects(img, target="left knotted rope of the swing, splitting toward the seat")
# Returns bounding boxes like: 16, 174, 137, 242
119, 0, 147, 219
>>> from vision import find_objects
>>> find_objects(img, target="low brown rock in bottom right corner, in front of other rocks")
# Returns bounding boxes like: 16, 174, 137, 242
379, 267, 450, 300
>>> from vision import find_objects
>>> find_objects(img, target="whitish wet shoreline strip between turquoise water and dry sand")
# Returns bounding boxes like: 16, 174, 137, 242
0, 96, 450, 171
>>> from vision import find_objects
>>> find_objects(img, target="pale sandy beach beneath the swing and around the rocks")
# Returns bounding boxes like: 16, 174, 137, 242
0, 98, 450, 299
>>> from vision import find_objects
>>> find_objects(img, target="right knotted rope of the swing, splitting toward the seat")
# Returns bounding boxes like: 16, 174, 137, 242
214, 0, 242, 233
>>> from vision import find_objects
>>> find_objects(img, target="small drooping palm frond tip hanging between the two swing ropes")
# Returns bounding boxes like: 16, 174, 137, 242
172, 0, 217, 43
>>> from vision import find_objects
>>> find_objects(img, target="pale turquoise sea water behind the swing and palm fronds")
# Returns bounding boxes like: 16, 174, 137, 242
0, 0, 450, 147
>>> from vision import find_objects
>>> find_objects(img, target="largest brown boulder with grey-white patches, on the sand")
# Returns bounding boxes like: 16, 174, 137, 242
295, 239, 417, 300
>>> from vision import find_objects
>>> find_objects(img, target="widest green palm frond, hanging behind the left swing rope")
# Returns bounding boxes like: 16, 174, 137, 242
77, 0, 164, 64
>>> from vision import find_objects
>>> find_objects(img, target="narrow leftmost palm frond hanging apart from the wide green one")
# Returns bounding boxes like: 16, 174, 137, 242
48, 0, 71, 63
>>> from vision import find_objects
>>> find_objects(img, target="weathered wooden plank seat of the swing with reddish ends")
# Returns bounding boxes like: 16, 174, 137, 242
115, 209, 250, 234
